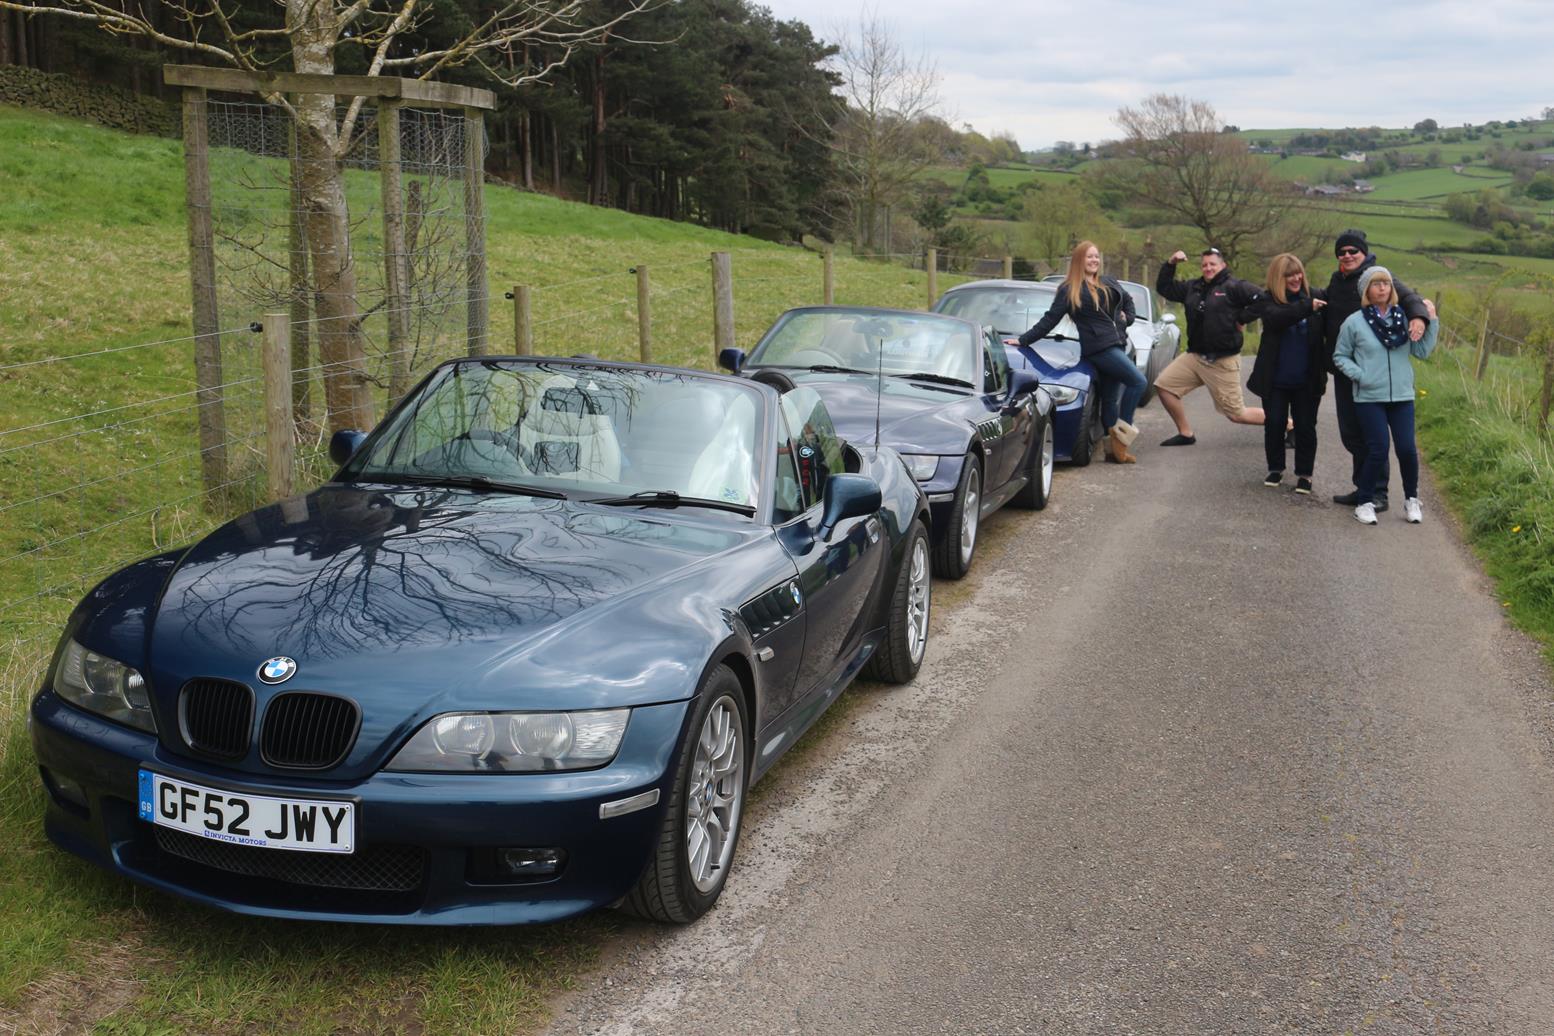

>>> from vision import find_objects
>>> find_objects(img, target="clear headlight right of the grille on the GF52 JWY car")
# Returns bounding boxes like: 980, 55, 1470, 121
387, 708, 631, 774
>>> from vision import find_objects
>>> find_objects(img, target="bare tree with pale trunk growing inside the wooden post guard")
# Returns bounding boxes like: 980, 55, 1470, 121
0, 0, 664, 427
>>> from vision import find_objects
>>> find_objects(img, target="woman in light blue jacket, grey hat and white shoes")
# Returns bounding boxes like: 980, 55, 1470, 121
1333, 266, 1437, 525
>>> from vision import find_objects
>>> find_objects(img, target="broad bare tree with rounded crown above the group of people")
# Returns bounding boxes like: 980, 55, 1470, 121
1102, 93, 1319, 261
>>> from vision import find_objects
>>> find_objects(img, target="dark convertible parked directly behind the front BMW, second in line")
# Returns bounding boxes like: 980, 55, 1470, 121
723, 306, 1054, 579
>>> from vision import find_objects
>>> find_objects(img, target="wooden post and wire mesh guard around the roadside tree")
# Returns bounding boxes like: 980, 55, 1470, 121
163, 65, 494, 488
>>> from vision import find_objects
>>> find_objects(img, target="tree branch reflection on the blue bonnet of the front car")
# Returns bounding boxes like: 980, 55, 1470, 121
152, 486, 749, 705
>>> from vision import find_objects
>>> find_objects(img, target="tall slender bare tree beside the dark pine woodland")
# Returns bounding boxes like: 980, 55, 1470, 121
824, 12, 945, 250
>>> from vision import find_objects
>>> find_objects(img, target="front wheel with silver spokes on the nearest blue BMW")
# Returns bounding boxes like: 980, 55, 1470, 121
623, 666, 751, 924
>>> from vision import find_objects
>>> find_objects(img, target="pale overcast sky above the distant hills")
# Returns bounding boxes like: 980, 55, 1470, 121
755, 0, 1554, 149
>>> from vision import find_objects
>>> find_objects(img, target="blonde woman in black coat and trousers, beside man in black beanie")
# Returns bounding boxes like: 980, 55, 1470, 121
1237, 252, 1329, 495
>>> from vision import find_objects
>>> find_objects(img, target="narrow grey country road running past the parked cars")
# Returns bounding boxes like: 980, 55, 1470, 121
552, 380, 1554, 1034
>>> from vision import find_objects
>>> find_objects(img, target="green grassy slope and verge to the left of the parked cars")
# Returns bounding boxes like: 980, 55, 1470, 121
0, 106, 926, 1033
